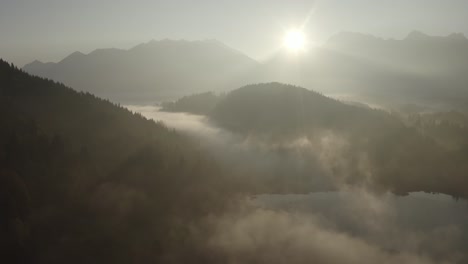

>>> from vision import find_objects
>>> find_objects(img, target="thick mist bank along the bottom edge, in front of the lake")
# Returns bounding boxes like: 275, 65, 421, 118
208, 206, 451, 264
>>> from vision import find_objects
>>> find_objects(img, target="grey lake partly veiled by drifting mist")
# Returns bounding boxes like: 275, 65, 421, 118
249, 188, 468, 263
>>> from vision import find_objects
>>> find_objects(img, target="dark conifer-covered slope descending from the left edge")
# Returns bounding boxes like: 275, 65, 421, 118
0, 61, 234, 263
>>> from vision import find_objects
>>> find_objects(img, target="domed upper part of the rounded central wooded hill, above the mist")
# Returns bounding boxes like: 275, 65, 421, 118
211, 83, 388, 134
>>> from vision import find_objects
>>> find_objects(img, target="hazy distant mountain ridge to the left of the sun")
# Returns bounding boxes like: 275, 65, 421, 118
23, 39, 257, 103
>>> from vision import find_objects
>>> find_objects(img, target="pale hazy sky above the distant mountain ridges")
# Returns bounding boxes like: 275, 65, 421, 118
0, 0, 468, 66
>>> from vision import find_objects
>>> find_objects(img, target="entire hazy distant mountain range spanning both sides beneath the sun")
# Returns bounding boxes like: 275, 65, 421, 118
23, 31, 468, 111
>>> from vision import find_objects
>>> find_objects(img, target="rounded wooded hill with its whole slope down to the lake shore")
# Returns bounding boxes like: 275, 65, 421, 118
164, 83, 468, 197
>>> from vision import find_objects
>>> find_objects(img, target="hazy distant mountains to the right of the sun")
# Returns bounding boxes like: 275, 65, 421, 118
262, 31, 468, 111
